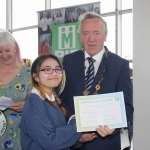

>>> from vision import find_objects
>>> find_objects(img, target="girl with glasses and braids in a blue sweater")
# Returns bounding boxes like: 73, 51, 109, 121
21, 54, 96, 150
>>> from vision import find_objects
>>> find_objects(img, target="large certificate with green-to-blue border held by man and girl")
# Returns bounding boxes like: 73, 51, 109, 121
74, 92, 127, 132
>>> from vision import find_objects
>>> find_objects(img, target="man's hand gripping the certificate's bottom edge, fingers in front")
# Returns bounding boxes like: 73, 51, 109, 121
96, 125, 115, 137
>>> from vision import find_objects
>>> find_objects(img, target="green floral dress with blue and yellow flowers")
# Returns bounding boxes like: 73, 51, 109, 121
0, 66, 32, 150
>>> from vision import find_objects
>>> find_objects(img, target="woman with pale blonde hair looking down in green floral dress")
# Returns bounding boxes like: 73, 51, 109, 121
0, 32, 31, 150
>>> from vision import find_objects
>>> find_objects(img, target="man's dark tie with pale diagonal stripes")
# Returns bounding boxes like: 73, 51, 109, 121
85, 57, 95, 91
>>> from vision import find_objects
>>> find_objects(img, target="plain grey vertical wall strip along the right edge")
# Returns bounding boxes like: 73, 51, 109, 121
133, 0, 150, 150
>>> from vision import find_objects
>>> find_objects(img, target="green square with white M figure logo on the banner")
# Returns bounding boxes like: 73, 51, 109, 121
52, 22, 82, 61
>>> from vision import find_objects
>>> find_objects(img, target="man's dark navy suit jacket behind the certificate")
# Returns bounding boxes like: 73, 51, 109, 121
60, 47, 133, 150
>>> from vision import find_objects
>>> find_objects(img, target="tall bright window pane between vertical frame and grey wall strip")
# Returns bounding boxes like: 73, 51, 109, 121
122, 13, 133, 60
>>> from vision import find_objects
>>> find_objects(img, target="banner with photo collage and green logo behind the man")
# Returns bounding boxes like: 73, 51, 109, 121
38, 2, 100, 61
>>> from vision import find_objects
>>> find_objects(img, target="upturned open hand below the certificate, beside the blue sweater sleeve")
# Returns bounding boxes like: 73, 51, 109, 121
79, 133, 97, 143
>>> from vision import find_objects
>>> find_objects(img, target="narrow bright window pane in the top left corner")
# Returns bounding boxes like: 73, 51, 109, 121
0, 0, 6, 29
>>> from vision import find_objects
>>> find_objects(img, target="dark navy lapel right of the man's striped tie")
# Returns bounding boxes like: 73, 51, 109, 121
89, 50, 109, 95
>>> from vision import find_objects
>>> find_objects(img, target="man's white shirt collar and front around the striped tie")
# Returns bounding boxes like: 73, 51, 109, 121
84, 47, 105, 76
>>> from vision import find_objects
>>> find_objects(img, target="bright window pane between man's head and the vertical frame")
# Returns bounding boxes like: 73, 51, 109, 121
103, 16, 116, 53
